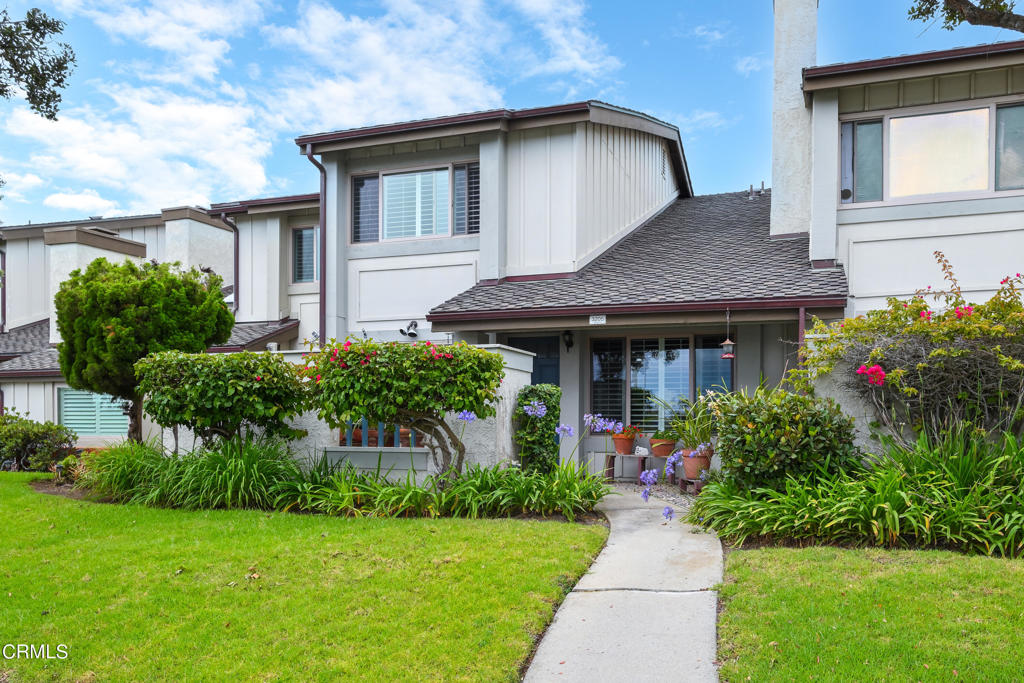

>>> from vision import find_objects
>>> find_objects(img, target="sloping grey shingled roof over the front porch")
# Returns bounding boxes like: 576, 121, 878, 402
427, 190, 848, 327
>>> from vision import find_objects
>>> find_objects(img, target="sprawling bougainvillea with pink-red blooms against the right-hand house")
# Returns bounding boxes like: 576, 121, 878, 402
795, 252, 1024, 434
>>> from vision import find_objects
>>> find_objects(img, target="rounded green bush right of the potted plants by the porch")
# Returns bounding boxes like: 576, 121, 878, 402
712, 387, 860, 488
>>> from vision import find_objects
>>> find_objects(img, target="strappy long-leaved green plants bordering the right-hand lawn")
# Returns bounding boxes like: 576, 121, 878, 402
689, 427, 1024, 557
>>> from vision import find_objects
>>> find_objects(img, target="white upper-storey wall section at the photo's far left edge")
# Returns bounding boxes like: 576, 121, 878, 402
5, 236, 50, 330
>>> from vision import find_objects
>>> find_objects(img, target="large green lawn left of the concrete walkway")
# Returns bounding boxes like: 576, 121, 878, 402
0, 473, 607, 681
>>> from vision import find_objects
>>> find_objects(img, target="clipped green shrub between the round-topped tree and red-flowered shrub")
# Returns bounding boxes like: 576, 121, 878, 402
135, 351, 309, 439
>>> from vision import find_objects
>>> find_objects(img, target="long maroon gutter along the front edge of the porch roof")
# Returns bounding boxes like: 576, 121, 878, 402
427, 297, 847, 323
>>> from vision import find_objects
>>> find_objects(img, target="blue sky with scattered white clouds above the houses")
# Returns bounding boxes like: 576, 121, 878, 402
0, 0, 1022, 224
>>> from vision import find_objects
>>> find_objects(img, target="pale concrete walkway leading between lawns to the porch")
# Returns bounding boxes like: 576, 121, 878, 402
524, 493, 722, 682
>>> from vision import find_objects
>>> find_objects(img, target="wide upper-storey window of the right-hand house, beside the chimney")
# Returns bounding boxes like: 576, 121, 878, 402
840, 103, 1024, 204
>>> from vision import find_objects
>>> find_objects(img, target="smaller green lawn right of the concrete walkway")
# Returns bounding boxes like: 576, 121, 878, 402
719, 547, 1024, 681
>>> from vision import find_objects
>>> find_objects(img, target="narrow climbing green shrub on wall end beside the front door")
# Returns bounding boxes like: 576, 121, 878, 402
512, 384, 562, 473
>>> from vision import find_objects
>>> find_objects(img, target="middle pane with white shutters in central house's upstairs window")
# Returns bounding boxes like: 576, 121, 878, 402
382, 168, 449, 240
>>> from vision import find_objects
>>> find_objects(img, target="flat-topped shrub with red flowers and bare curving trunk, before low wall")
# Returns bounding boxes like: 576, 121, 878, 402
303, 339, 504, 473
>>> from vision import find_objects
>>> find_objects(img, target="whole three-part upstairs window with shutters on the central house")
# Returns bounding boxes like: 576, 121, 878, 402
352, 162, 480, 243
